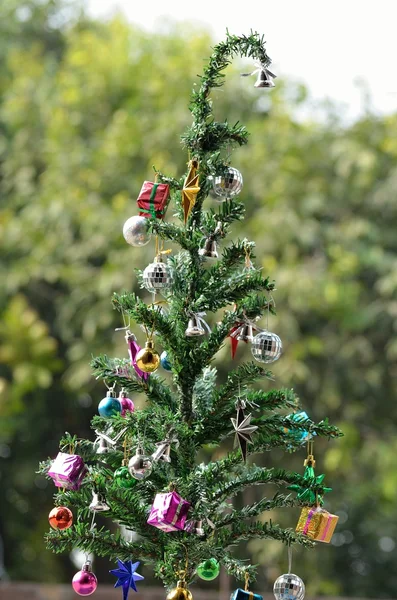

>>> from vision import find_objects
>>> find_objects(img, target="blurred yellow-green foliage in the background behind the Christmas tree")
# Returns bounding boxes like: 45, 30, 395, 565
0, 0, 397, 598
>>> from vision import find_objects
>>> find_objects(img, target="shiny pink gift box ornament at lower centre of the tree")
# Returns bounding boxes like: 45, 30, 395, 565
147, 492, 190, 532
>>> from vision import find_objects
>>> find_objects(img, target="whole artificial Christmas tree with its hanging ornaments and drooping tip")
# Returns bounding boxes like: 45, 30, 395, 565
41, 34, 340, 598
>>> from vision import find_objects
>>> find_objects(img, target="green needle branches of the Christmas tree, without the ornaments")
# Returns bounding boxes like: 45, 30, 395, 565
41, 33, 341, 586
